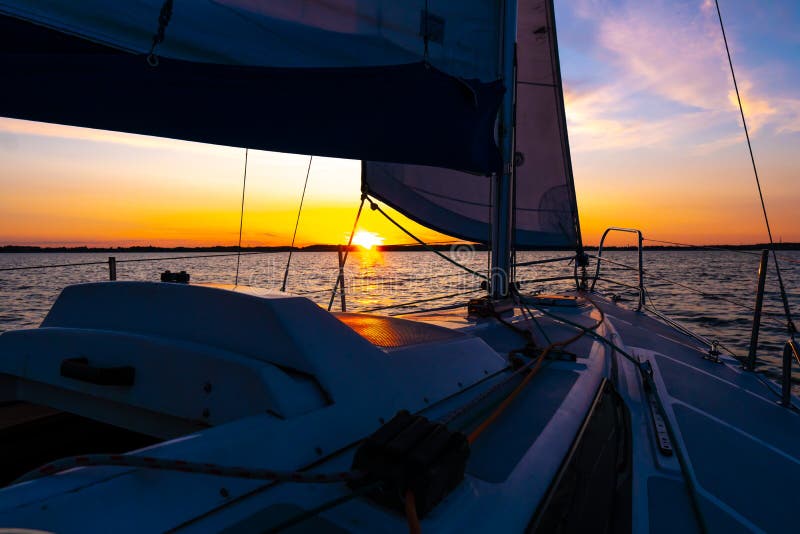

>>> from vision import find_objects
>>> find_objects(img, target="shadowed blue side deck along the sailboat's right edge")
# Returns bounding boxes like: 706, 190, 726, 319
598, 301, 800, 532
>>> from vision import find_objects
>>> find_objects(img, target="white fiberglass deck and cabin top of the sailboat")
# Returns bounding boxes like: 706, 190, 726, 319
0, 283, 800, 532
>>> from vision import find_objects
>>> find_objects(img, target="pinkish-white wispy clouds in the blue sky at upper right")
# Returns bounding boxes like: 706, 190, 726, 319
562, 0, 800, 150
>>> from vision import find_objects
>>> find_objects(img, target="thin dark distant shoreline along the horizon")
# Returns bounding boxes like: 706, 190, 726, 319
0, 243, 800, 254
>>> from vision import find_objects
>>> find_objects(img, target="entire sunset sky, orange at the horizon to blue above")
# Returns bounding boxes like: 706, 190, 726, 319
0, 0, 800, 246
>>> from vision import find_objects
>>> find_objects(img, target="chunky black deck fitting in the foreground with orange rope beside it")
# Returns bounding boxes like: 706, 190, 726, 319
350, 410, 470, 517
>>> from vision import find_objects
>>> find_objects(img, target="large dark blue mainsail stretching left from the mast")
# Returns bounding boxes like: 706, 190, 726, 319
0, 0, 502, 172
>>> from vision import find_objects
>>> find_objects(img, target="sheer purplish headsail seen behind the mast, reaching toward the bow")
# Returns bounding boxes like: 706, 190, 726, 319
363, 0, 580, 248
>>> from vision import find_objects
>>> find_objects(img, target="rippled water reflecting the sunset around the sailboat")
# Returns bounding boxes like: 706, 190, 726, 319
0, 247, 800, 388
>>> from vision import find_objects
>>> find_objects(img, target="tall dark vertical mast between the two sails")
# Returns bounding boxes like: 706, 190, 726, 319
490, 0, 517, 299
